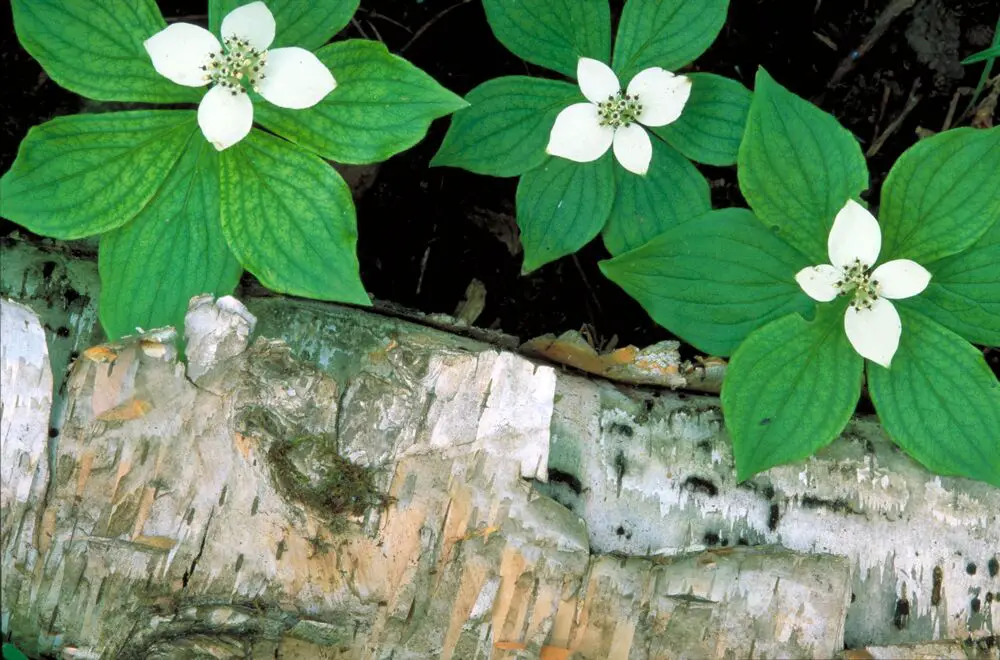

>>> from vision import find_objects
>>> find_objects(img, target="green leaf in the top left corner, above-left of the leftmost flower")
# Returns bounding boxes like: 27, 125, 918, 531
11, 0, 202, 103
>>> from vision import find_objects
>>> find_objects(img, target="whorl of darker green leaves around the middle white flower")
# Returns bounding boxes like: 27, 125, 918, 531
431, 0, 750, 272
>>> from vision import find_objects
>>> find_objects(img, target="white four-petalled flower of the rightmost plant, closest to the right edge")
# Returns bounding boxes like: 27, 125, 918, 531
795, 200, 931, 368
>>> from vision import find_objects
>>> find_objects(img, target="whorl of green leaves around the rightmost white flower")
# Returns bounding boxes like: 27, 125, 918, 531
601, 65, 1000, 485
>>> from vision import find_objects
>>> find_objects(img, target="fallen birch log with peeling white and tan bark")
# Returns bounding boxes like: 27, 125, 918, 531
0, 237, 1000, 659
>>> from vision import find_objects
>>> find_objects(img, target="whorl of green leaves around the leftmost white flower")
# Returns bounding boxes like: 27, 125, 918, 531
0, 0, 467, 337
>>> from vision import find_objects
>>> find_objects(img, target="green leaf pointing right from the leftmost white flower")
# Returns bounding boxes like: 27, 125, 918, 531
254, 39, 467, 163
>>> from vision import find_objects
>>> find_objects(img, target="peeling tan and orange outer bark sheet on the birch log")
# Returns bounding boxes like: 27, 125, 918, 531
3, 299, 850, 658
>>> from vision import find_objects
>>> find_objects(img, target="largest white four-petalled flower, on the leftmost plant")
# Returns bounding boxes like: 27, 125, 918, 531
143, 2, 337, 151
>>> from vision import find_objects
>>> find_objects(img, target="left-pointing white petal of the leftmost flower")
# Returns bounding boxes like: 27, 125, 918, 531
142, 23, 222, 87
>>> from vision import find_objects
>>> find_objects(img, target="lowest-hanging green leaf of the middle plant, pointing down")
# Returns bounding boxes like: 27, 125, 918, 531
516, 151, 615, 273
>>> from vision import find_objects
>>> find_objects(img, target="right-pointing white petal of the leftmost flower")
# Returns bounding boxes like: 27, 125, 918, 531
257, 46, 337, 110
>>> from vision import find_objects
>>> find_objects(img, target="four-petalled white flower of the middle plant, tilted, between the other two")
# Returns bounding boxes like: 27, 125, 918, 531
545, 57, 691, 174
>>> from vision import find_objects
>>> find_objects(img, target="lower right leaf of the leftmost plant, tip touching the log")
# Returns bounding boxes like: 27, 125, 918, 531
220, 130, 371, 305
